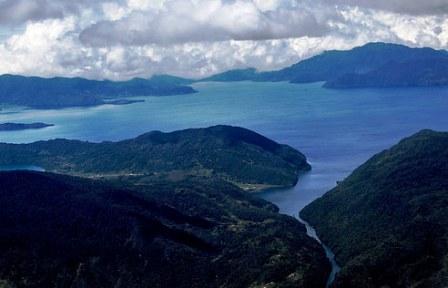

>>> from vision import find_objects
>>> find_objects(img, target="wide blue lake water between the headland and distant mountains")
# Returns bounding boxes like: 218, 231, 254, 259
0, 82, 448, 215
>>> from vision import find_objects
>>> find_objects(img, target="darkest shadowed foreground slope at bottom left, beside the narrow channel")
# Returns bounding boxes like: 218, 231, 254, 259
0, 172, 329, 288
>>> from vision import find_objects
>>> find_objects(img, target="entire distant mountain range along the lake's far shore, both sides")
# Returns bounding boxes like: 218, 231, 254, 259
0, 43, 448, 109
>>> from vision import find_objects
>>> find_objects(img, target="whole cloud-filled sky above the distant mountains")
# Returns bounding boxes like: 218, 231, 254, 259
0, 0, 448, 80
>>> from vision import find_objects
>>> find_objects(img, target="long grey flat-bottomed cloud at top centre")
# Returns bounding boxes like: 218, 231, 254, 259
80, 0, 329, 46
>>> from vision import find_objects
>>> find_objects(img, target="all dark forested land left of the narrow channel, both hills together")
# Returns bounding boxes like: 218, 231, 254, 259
0, 126, 330, 288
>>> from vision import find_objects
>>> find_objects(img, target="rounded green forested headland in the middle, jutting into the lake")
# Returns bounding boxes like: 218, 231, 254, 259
0, 126, 310, 189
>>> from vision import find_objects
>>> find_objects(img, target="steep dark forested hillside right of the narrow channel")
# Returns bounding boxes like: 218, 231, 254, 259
301, 130, 448, 287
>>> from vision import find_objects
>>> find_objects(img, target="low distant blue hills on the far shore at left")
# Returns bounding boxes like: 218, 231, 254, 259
0, 75, 195, 109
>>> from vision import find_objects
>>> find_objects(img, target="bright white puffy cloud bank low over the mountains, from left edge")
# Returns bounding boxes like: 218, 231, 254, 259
0, 16, 353, 80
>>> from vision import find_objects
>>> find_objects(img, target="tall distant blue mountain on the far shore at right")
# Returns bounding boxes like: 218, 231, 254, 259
199, 43, 448, 88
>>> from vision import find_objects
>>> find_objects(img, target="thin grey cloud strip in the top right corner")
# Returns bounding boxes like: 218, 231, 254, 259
324, 0, 448, 15
